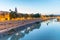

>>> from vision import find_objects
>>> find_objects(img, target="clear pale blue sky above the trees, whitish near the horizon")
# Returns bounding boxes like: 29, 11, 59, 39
0, 0, 60, 14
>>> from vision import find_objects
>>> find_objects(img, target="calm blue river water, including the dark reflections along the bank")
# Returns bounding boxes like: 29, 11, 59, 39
0, 19, 60, 40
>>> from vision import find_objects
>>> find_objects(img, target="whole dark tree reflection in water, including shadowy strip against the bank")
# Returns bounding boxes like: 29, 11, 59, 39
2, 22, 41, 40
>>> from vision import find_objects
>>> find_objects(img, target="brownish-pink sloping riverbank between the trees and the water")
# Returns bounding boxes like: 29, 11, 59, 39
0, 18, 53, 33
